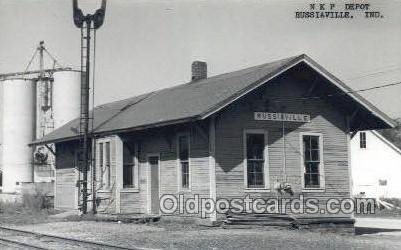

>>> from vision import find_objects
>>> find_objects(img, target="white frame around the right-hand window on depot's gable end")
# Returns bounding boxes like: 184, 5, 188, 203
299, 132, 326, 192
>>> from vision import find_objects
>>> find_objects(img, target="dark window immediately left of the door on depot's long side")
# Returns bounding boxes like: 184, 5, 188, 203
123, 142, 135, 188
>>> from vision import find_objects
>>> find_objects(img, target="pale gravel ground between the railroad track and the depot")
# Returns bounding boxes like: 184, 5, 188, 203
8, 221, 401, 249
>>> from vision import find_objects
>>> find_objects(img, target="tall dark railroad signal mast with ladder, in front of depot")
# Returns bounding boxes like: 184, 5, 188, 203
72, 0, 106, 214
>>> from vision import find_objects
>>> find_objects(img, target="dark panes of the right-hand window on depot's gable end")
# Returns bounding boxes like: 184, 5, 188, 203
302, 135, 322, 188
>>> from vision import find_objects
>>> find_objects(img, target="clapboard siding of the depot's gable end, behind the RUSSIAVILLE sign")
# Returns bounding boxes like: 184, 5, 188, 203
216, 73, 350, 217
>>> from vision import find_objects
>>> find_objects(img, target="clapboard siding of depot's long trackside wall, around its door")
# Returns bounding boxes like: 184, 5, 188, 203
90, 126, 210, 213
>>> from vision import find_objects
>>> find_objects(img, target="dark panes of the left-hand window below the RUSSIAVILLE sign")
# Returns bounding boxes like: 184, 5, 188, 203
245, 132, 266, 188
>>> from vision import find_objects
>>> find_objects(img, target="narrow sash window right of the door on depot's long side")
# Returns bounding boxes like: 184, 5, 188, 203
178, 135, 190, 189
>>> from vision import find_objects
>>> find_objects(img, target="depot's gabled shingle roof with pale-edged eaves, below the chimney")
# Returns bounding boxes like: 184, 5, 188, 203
33, 55, 394, 144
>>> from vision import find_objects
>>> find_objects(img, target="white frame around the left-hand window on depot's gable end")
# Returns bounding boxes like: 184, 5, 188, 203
242, 129, 270, 192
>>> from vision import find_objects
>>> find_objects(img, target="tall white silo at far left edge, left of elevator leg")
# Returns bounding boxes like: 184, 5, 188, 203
1, 79, 36, 193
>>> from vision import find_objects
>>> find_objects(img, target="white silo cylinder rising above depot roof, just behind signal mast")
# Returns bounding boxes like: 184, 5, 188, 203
53, 70, 81, 129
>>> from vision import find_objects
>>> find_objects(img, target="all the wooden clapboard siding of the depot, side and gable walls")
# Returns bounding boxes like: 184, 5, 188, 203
56, 72, 350, 219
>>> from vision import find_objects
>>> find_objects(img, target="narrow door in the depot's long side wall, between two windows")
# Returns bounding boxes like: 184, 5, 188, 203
148, 155, 160, 214
